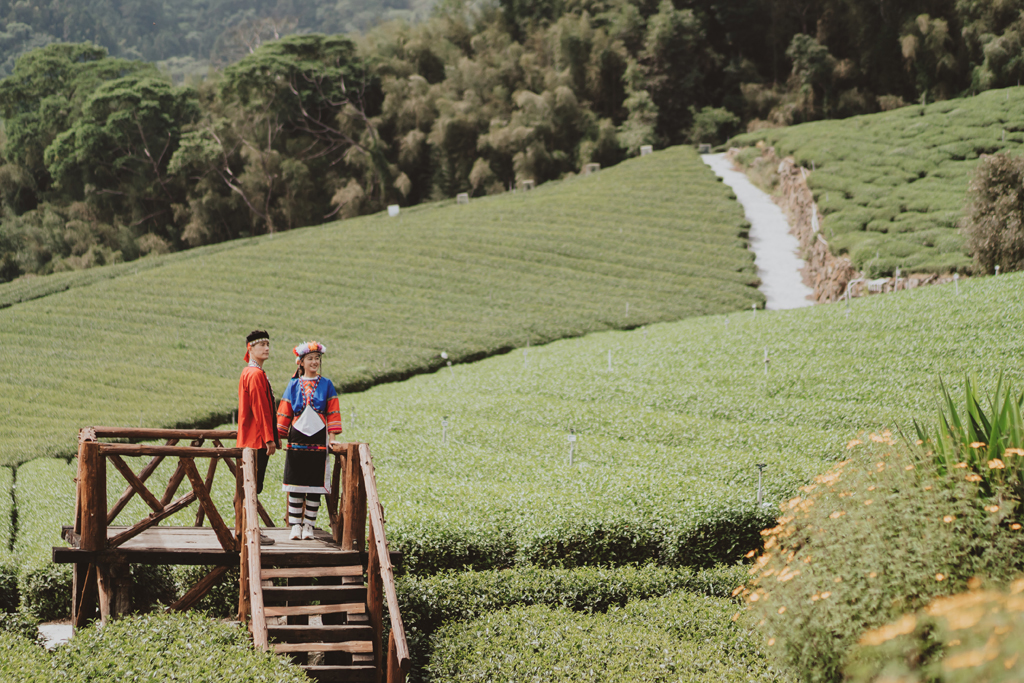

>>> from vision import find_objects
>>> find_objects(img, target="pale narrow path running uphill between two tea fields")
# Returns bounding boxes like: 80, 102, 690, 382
700, 154, 814, 310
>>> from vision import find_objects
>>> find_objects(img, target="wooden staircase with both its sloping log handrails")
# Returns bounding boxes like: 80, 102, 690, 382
239, 443, 410, 683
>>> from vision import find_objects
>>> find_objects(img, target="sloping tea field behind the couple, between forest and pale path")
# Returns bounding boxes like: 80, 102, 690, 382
0, 147, 763, 465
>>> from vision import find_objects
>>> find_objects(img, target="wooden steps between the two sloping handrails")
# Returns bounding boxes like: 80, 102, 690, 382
260, 552, 380, 683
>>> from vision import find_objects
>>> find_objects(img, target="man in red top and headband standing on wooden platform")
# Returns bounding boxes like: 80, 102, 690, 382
237, 330, 281, 546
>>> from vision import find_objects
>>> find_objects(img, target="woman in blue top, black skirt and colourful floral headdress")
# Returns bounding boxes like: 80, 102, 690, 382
278, 341, 341, 540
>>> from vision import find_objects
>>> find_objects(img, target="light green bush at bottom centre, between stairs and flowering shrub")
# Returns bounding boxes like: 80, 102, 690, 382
428, 593, 787, 683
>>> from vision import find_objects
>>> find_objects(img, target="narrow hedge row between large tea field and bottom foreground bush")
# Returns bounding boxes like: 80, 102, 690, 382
398, 566, 744, 681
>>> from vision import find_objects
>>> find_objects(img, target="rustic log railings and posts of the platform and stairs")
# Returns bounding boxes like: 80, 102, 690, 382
62, 427, 410, 683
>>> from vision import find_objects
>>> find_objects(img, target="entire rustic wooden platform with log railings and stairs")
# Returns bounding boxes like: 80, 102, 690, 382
53, 427, 410, 683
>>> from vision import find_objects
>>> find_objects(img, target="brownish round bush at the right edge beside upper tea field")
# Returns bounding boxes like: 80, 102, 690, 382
963, 154, 1024, 272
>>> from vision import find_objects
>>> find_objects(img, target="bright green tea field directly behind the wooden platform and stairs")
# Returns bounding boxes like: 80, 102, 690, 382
15, 274, 1024, 598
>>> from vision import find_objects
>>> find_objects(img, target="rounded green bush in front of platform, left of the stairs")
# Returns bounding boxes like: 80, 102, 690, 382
50, 612, 308, 683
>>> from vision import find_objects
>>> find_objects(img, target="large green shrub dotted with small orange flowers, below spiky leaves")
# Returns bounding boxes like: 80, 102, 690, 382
734, 432, 1024, 681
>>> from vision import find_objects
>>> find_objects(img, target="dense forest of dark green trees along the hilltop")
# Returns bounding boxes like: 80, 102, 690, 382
0, 0, 1024, 282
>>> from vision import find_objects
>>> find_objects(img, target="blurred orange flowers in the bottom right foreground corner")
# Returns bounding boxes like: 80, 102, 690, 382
845, 579, 1024, 683
